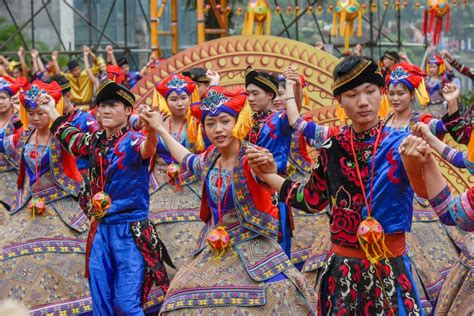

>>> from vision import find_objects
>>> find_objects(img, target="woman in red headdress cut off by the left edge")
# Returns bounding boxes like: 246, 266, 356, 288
0, 77, 23, 206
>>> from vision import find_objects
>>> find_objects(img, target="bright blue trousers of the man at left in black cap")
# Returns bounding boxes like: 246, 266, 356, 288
89, 223, 145, 316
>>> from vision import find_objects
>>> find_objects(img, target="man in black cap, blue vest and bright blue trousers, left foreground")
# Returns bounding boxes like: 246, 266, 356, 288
42, 80, 169, 315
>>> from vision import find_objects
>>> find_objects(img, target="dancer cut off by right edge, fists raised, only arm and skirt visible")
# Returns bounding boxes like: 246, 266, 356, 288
401, 136, 474, 315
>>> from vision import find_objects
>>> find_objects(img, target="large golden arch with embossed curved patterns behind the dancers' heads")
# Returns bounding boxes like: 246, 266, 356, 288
132, 36, 339, 119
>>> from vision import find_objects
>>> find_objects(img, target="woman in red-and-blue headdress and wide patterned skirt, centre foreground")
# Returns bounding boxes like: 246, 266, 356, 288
142, 86, 315, 315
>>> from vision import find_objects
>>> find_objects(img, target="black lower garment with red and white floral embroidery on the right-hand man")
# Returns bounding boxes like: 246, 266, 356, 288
318, 255, 421, 315
